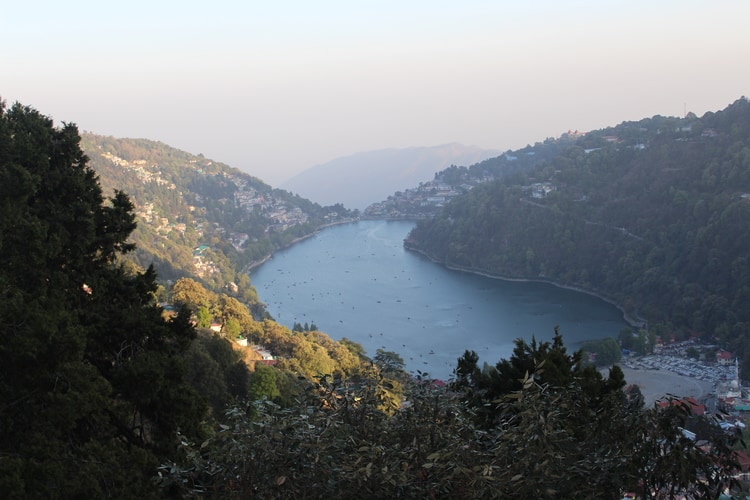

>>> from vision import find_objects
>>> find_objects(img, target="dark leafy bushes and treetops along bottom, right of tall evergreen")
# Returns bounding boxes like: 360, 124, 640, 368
160, 334, 736, 499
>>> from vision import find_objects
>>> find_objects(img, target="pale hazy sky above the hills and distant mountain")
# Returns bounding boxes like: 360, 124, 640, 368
0, 0, 750, 185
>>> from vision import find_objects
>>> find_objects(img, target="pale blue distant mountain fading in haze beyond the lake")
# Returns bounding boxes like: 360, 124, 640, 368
279, 142, 501, 210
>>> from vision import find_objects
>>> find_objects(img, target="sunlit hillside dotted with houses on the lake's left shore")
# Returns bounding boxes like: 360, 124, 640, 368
82, 134, 352, 306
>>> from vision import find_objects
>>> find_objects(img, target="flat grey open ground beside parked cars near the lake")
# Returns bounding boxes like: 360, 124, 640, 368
620, 365, 714, 407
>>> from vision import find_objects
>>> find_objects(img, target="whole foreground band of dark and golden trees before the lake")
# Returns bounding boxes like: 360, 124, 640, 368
0, 103, 745, 499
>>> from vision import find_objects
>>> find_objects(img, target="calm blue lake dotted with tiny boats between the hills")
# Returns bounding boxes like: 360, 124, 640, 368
250, 221, 628, 380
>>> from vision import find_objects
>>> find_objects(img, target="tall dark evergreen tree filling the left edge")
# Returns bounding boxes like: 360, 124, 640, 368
0, 103, 205, 498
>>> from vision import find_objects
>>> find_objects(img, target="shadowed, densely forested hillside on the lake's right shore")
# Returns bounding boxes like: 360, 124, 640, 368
407, 98, 750, 373
